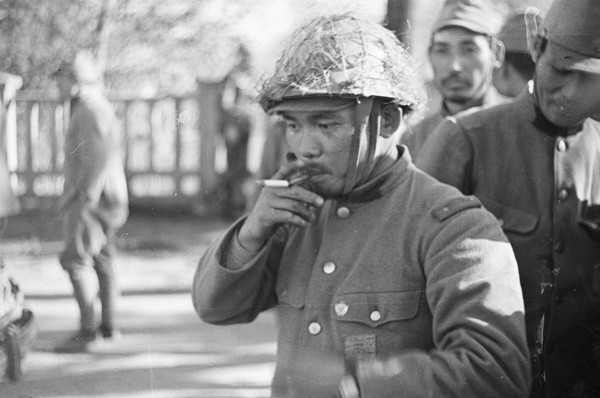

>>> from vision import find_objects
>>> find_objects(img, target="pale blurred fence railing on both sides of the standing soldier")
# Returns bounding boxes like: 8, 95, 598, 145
6, 83, 227, 213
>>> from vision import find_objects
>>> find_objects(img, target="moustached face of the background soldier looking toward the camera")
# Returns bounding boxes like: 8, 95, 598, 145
429, 27, 495, 102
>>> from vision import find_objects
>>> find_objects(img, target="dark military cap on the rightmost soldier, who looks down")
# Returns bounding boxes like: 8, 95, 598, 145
539, 0, 600, 74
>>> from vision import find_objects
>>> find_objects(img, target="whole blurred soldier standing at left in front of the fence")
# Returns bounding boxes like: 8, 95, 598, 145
56, 50, 129, 352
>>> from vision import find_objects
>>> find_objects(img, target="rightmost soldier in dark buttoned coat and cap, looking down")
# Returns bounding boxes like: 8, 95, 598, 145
416, 0, 600, 398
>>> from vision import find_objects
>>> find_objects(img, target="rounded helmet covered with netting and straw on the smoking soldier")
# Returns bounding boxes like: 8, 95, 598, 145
259, 14, 424, 113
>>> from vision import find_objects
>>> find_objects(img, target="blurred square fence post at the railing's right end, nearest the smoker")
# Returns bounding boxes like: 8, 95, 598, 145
196, 81, 221, 214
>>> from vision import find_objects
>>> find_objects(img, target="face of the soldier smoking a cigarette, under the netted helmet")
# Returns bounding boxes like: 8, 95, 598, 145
281, 106, 355, 198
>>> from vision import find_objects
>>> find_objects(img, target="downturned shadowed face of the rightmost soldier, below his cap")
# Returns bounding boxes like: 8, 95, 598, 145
535, 45, 600, 128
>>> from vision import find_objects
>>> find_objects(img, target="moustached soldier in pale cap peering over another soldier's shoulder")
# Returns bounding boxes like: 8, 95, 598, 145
400, 0, 506, 159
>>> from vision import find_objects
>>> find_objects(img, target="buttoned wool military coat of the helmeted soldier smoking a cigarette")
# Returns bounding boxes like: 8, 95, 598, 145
193, 153, 529, 398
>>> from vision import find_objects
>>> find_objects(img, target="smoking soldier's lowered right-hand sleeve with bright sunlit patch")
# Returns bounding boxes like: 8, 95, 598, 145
357, 205, 530, 398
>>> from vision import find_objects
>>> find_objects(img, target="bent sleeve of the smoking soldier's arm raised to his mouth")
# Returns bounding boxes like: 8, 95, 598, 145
192, 218, 280, 325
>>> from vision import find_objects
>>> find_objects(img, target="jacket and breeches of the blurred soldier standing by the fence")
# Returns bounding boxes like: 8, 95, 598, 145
61, 87, 128, 268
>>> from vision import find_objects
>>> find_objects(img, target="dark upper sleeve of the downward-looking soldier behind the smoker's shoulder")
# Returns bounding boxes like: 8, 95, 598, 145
415, 117, 473, 195
